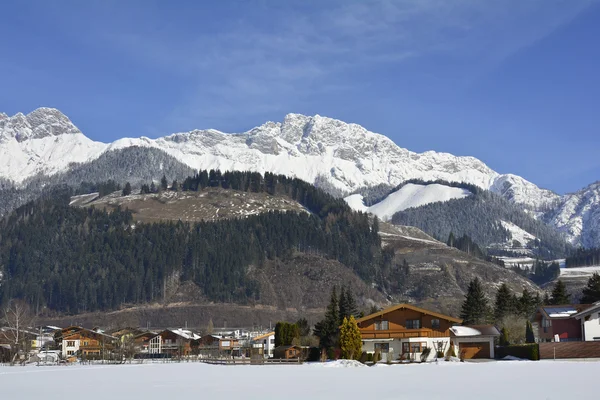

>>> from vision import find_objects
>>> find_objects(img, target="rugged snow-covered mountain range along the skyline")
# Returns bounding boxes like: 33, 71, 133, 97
0, 108, 599, 247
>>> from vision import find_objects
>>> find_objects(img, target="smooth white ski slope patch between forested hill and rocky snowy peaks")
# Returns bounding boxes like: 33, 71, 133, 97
345, 183, 471, 221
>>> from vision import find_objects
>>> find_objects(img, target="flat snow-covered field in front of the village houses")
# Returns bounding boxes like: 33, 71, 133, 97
0, 361, 600, 400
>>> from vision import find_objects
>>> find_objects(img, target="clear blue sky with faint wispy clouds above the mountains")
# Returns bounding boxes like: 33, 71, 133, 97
0, 0, 600, 193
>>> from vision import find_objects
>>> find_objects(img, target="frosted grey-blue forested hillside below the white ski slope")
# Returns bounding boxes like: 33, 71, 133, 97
392, 190, 569, 259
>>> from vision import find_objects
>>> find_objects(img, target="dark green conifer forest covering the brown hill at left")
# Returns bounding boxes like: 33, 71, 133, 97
0, 171, 391, 313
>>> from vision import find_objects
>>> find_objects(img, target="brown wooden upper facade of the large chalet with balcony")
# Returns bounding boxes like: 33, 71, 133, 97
356, 304, 462, 339
